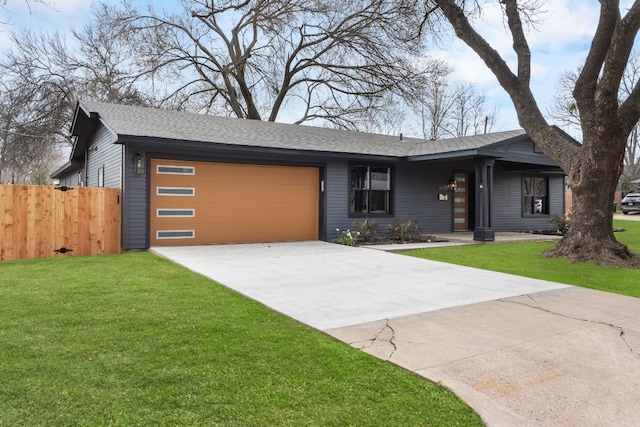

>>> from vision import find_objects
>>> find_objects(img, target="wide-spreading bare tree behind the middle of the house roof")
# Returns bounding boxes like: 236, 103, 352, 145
104, 0, 436, 128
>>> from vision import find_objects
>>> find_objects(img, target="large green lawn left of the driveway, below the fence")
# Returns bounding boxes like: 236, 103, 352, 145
0, 253, 482, 426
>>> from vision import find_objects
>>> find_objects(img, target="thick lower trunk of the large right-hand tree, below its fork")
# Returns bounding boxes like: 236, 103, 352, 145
544, 136, 640, 267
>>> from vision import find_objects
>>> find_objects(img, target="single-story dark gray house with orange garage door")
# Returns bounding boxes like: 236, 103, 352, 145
52, 102, 577, 250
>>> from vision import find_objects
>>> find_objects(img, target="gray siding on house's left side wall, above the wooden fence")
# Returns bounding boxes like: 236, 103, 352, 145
85, 124, 123, 188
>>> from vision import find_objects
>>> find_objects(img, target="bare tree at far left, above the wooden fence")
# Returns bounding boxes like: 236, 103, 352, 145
0, 5, 153, 183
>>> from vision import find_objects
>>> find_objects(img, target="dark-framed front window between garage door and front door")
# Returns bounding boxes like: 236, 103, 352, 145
349, 164, 391, 214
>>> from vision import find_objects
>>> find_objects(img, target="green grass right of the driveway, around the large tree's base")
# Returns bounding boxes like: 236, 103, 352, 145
405, 220, 640, 297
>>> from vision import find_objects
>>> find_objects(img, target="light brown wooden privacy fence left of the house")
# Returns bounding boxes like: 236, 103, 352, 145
0, 185, 120, 262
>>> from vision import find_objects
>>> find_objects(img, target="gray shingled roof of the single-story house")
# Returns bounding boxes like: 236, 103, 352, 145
79, 101, 525, 158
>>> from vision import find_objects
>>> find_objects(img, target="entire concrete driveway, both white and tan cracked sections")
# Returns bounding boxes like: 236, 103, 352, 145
152, 242, 640, 426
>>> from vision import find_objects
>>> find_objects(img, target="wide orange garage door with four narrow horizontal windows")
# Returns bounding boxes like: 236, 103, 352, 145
150, 159, 319, 246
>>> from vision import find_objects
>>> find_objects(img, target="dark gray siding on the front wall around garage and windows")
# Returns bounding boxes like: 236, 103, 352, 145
117, 144, 564, 249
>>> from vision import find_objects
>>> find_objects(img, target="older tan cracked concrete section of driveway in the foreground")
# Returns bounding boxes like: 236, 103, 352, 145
327, 288, 640, 427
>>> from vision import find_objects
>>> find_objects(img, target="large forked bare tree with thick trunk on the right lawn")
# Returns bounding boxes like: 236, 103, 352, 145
431, 0, 640, 267
